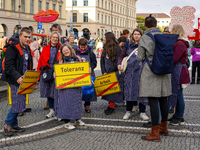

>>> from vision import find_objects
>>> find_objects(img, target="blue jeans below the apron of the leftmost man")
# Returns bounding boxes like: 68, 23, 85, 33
5, 107, 18, 127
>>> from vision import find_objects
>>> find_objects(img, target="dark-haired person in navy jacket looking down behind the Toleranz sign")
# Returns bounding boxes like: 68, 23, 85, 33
76, 38, 97, 113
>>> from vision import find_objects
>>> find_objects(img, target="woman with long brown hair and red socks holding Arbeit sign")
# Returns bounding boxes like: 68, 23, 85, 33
101, 32, 124, 115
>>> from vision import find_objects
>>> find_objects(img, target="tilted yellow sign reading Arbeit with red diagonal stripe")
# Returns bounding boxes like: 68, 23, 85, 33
94, 72, 121, 96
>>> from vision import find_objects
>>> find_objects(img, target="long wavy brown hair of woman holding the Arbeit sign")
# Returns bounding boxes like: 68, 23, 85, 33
102, 32, 118, 62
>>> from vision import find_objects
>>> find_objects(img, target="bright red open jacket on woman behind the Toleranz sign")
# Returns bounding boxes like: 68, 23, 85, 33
37, 43, 60, 71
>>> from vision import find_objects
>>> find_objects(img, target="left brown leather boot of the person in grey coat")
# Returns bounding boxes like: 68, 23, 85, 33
142, 126, 160, 142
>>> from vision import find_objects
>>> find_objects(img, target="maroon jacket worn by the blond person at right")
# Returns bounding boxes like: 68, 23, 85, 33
173, 39, 190, 84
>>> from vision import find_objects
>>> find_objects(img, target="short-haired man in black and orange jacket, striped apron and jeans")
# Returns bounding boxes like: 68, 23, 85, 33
1, 27, 34, 136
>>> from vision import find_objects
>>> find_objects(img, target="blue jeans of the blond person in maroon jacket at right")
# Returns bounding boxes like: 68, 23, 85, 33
175, 85, 185, 118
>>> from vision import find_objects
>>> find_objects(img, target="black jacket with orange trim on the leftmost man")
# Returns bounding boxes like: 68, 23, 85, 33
1, 38, 34, 86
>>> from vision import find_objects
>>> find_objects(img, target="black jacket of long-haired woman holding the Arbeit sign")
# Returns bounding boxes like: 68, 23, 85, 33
100, 45, 122, 74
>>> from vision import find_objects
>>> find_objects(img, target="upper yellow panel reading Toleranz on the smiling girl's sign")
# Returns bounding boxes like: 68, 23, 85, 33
54, 62, 90, 77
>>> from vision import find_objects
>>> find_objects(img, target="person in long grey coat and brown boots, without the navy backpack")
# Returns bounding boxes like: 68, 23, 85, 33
137, 15, 173, 141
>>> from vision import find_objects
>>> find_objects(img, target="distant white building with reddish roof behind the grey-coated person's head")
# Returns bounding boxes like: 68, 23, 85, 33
136, 12, 172, 28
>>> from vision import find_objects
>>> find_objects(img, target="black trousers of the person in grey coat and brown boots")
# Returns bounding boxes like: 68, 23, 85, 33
148, 97, 169, 126
